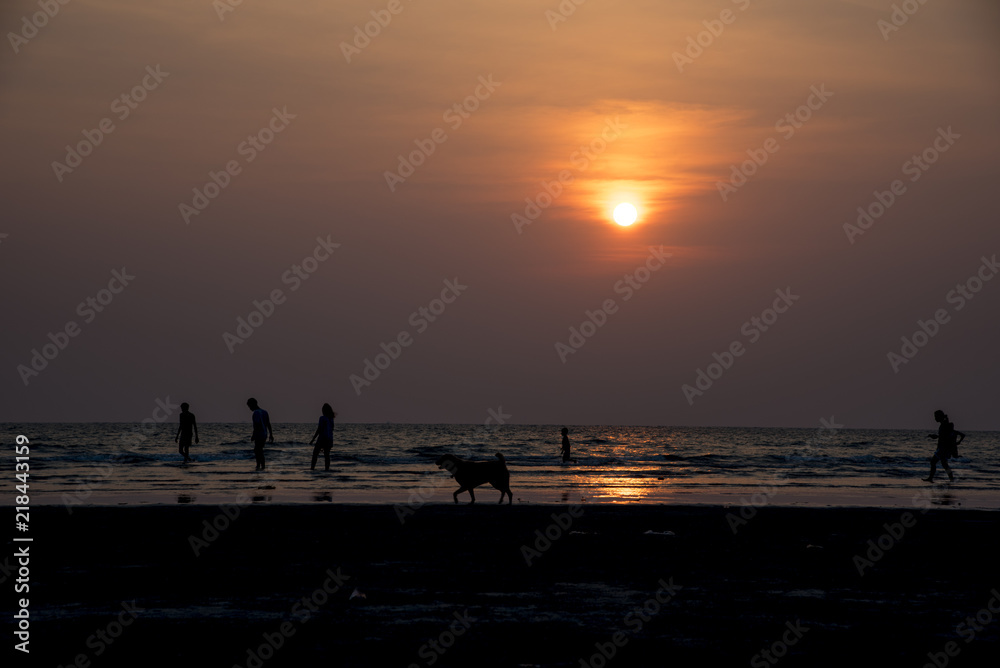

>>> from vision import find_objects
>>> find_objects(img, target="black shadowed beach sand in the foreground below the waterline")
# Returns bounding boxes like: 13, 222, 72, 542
15, 504, 1000, 668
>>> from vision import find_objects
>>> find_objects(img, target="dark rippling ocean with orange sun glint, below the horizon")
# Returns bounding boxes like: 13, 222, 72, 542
0, 423, 1000, 510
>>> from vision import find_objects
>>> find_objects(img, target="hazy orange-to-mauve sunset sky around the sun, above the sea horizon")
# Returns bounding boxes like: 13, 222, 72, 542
0, 0, 1000, 428
